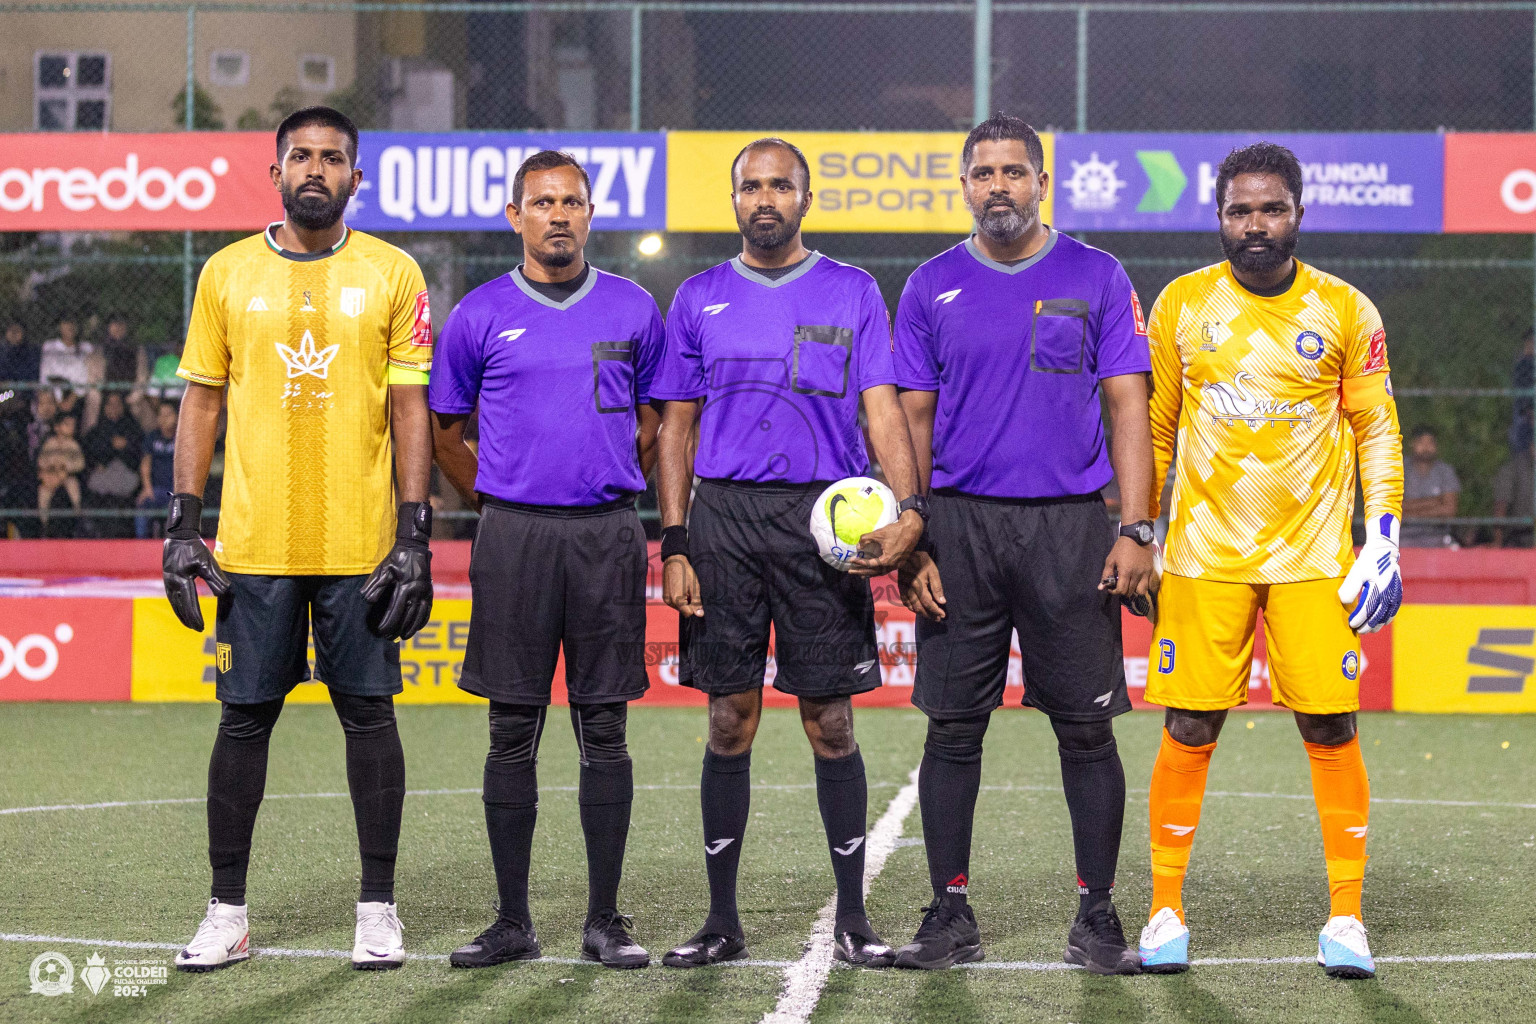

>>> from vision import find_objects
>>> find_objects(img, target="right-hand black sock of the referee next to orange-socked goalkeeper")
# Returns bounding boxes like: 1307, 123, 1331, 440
1058, 737, 1126, 915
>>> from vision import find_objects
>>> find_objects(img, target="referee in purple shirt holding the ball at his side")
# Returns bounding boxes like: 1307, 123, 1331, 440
651, 138, 925, 967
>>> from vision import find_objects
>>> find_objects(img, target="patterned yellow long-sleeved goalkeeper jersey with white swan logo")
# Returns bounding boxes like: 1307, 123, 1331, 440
1147, 261, 1402, 583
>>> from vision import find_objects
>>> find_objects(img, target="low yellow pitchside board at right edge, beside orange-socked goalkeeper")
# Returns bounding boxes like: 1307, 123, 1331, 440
1392, 605, 1536, 712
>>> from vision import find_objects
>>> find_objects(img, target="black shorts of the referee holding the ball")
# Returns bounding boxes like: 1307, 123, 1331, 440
679, 481, 880, 697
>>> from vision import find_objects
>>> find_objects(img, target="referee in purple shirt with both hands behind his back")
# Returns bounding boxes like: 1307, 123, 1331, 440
429, 150, 664, 967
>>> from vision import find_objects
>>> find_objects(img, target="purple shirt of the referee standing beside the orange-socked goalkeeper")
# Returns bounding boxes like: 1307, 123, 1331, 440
895, 229, 1152, 497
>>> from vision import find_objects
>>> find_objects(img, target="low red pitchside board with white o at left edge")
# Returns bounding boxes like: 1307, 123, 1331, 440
0, 597, 134, 700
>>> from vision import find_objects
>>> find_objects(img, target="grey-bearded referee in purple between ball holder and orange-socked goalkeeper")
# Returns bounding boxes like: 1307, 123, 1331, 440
895, 115, 1154, 973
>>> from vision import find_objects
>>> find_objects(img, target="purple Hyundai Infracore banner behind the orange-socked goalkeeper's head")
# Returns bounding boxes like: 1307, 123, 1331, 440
1051, 132, 1445, 233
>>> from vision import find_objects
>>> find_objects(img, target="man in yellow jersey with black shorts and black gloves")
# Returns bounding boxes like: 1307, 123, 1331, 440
164, 107, 432, 972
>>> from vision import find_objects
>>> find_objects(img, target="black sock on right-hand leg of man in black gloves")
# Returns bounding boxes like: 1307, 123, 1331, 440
330, 691, 406, 903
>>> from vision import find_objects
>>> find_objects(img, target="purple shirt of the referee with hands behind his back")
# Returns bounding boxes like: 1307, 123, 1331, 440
427, 267, 665, 505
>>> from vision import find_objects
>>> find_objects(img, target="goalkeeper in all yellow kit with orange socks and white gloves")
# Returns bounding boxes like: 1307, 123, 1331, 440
1141, 143, 1402, 978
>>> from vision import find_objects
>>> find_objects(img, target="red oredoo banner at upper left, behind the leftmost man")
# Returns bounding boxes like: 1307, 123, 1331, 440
0, 132, 273, 232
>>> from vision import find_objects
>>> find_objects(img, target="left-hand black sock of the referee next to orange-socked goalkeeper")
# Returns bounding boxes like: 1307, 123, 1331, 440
917, 715, 988, 904
